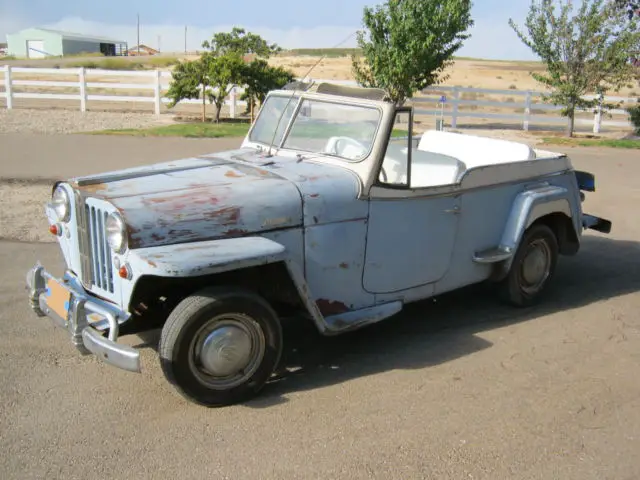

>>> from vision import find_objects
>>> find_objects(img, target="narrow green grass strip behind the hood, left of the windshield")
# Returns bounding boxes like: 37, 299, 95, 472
89, 122, 249, 138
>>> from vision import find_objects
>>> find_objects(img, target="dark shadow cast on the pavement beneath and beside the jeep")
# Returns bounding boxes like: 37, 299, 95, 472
245, 233, 640, 408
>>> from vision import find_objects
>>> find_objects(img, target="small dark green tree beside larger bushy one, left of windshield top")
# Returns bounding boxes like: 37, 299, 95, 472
242, 58, 295, 121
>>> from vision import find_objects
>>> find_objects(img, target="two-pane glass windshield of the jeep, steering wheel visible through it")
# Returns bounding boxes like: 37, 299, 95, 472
249, 96, 381, 161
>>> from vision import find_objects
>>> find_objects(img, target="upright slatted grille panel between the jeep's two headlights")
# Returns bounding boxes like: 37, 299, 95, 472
78, 203, 115, 293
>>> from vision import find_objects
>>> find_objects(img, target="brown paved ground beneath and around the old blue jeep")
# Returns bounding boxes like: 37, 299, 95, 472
0, 136, 640, 480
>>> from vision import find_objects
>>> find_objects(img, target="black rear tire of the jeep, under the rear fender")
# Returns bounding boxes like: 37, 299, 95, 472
498, 224, 559, 307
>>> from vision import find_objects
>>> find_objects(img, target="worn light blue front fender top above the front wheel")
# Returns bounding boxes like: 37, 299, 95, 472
127, 237, 286, 278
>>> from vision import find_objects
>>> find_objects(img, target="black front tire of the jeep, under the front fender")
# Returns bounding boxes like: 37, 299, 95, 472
159, 288, 283, 407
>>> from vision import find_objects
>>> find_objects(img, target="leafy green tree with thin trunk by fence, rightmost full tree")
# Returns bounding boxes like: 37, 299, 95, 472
509, 0, 640, 137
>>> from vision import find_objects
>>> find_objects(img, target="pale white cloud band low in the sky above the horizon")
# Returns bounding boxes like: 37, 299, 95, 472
0, 16, 535, 60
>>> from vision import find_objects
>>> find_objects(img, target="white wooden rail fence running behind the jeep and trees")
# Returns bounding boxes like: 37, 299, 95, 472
0, 66, 637, 133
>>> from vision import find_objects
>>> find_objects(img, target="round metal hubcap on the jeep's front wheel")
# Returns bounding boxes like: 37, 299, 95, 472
190, 314, 265, 389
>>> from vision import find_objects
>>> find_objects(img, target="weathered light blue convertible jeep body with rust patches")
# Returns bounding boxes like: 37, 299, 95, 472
27, 83, 606, 371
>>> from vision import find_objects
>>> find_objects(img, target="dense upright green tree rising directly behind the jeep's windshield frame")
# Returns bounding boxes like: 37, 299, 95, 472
352, 0, 473, 105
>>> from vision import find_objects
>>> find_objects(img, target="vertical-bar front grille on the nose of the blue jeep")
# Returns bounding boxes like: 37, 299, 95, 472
85, 205, 113, 293
